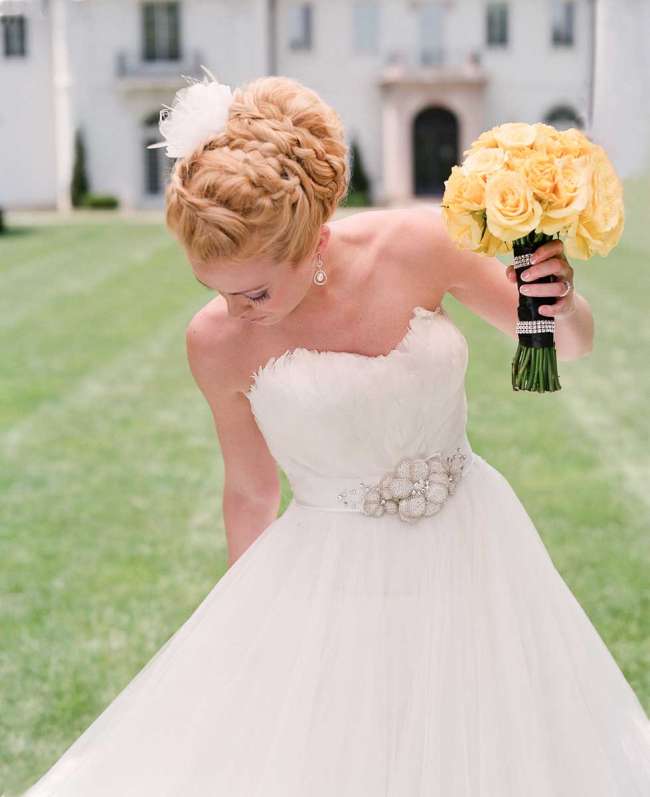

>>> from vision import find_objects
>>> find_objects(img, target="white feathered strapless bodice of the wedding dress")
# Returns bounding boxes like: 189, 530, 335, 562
245, 306, 471, 508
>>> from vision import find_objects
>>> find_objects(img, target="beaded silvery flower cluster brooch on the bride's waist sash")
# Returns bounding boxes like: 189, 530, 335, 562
337, 448, 467, 523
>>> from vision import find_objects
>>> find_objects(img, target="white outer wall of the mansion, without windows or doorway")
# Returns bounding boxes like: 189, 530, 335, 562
0, 0, 616, 207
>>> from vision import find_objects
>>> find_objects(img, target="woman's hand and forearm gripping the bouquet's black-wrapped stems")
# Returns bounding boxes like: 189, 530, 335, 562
506, 240, 594, 360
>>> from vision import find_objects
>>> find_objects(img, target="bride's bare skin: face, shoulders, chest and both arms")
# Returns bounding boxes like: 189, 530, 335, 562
187, 183, 593, 564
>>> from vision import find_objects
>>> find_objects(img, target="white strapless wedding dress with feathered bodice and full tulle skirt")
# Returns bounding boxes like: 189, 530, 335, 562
26, 306, 650, 797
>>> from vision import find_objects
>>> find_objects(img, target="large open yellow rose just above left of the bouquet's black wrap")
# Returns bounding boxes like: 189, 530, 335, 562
485, 171, 542, 241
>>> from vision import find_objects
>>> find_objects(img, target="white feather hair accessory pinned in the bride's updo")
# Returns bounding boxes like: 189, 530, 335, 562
147, 64, 232, 158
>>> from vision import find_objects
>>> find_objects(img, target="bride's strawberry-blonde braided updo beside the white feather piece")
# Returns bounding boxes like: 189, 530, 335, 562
165, 76, 350, 264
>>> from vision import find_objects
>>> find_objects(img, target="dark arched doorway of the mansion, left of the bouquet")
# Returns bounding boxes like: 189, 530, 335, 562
413, 107, 458, 196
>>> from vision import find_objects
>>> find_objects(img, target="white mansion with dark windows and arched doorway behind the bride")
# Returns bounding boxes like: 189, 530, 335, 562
0, 0, 650, 209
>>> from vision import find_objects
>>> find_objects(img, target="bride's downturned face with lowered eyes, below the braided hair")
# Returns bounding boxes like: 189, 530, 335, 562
190, 225, 330, 325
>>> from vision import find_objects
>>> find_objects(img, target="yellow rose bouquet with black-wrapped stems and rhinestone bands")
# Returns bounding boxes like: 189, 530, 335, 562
442, 122, 624, 393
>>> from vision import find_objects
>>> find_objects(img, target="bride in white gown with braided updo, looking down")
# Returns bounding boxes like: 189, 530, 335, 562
27, 71, 650, 797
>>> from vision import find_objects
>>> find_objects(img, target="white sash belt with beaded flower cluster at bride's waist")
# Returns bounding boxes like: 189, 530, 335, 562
294, 441, 474, 523
